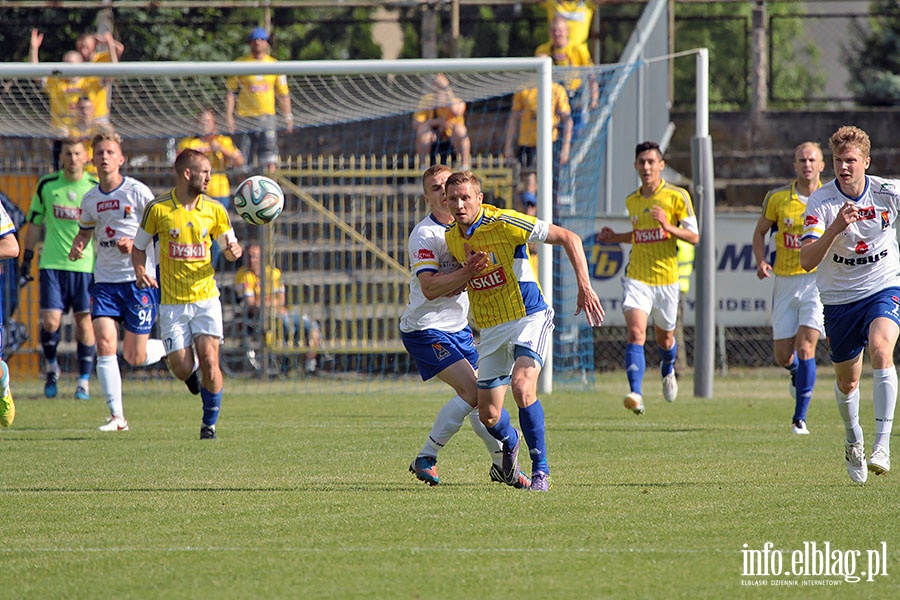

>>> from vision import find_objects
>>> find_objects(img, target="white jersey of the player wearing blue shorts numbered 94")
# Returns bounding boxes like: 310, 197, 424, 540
79, 177, 156, 283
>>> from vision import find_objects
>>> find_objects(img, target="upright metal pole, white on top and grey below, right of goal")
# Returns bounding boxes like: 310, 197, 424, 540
691, 48, 716, 398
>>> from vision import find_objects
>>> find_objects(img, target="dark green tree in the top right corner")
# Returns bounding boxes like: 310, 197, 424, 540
849, 0, 900, 106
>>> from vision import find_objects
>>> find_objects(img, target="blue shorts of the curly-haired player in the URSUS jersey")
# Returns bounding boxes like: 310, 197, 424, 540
824, 287, 900, 363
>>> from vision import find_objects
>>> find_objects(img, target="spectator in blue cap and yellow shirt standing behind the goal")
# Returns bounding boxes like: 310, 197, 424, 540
225, 27, 294, 173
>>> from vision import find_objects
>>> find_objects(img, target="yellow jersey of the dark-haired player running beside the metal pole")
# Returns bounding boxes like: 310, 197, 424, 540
625, 181, 694, 285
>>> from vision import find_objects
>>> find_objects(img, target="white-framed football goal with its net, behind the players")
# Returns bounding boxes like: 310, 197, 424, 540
0, 58, 634, 390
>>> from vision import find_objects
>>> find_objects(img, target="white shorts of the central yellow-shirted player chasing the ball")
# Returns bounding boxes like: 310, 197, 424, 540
478, 308, 553, 382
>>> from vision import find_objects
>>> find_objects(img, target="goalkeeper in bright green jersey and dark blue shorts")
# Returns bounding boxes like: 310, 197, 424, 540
19, 140, 97, 400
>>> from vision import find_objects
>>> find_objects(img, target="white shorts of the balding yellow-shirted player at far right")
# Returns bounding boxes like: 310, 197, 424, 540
772, 273, 825, 340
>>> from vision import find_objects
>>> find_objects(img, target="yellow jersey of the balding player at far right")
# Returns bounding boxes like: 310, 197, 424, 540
763, 181, 820, 277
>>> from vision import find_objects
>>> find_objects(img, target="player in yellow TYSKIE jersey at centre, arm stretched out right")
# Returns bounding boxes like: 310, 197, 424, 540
445, 171, 603, 492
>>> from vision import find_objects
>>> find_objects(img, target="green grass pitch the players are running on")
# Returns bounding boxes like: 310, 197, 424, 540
0, 369, 900, 599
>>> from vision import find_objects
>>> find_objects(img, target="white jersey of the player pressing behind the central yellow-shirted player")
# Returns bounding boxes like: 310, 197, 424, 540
400, 215, 469, 333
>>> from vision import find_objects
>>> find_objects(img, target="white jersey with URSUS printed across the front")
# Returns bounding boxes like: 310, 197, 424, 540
802, 176, 900, 305
